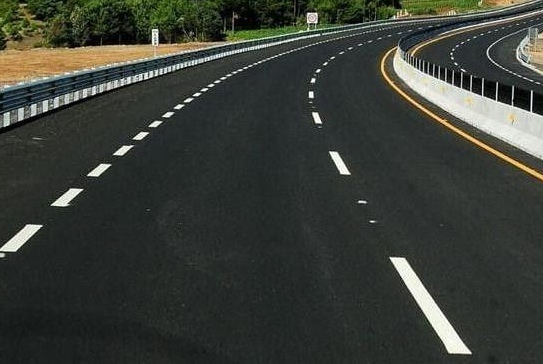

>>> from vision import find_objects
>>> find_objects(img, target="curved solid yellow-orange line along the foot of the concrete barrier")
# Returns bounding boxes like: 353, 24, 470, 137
381, 47, 543, 182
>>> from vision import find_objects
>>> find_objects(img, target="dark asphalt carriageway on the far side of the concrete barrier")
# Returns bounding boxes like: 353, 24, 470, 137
416, 14, 543, 92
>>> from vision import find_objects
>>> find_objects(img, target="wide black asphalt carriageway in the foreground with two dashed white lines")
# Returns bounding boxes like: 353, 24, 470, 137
0, 12, 543, 363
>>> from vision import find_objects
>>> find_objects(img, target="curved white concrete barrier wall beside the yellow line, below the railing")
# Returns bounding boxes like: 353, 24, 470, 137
394, 51, 543, 159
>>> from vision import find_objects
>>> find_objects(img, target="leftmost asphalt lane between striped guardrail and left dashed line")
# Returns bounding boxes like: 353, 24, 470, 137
0, 26, 412, 256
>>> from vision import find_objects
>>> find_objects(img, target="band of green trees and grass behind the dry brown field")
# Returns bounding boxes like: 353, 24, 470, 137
0, 0, 399, 47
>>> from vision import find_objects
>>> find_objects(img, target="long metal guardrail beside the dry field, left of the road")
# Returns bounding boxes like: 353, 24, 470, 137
0, 21, 396, 128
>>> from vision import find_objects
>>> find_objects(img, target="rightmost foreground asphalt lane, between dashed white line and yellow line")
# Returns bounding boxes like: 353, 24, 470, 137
314, 27, 543, 363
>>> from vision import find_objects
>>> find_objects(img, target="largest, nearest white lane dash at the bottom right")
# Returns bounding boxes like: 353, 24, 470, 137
390, 257, 471, 355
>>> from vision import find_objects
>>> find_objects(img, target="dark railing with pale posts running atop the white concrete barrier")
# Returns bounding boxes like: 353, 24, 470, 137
398, 3, 543, 115
